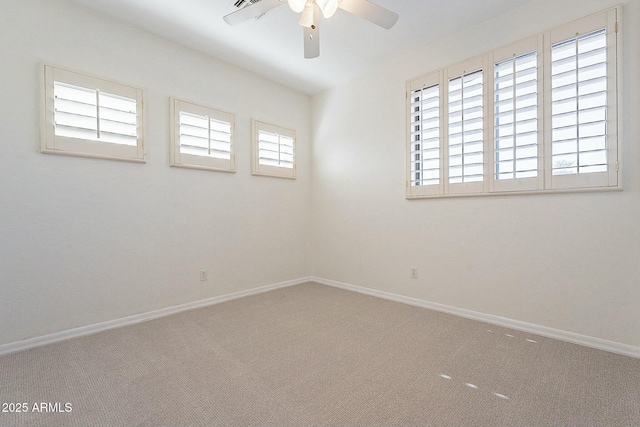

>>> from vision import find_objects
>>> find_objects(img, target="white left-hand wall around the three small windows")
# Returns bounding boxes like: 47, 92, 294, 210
0, 0, 310, 344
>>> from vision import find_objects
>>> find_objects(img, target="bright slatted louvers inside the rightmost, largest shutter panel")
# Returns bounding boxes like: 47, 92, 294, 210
551, 29, 608, 175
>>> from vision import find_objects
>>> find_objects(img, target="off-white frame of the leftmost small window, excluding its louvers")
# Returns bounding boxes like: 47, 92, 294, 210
40, 64, 145, 163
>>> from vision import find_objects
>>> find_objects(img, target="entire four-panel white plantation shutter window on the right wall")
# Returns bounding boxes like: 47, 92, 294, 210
406, 7, 620, 198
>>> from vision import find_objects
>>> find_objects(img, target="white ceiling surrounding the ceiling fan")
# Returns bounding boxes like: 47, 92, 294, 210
73, 0, 531, 94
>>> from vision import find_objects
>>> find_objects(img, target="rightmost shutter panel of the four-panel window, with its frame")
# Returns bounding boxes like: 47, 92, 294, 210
549, 10, 617, 188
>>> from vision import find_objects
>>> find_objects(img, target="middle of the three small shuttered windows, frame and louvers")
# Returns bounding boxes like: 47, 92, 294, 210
171, 99, 235, 172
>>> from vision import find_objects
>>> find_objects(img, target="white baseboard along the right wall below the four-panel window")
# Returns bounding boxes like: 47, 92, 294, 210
311, 277, 640, 358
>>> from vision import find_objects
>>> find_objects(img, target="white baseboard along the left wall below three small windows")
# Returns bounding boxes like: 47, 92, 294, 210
0, 277, 311, 356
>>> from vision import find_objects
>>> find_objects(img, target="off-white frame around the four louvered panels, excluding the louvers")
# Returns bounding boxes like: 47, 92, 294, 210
405, 6, 622, 199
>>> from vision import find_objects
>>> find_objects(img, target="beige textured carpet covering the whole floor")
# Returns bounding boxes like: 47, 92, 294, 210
0, 283, 640, 426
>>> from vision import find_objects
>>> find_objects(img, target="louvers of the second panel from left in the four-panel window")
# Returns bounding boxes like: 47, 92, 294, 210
448, 70, 484, 184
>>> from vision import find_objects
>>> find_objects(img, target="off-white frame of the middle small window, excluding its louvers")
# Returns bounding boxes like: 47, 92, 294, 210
169, 98, 236, 173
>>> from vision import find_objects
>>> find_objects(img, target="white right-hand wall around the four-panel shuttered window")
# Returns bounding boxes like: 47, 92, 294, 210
312, 0, 640, 346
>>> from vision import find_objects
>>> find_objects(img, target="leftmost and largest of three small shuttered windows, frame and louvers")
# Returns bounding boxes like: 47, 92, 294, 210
41, 65, 144, 161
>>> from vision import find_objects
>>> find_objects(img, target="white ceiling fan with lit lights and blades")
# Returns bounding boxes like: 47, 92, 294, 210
224, 0, 398, 59
